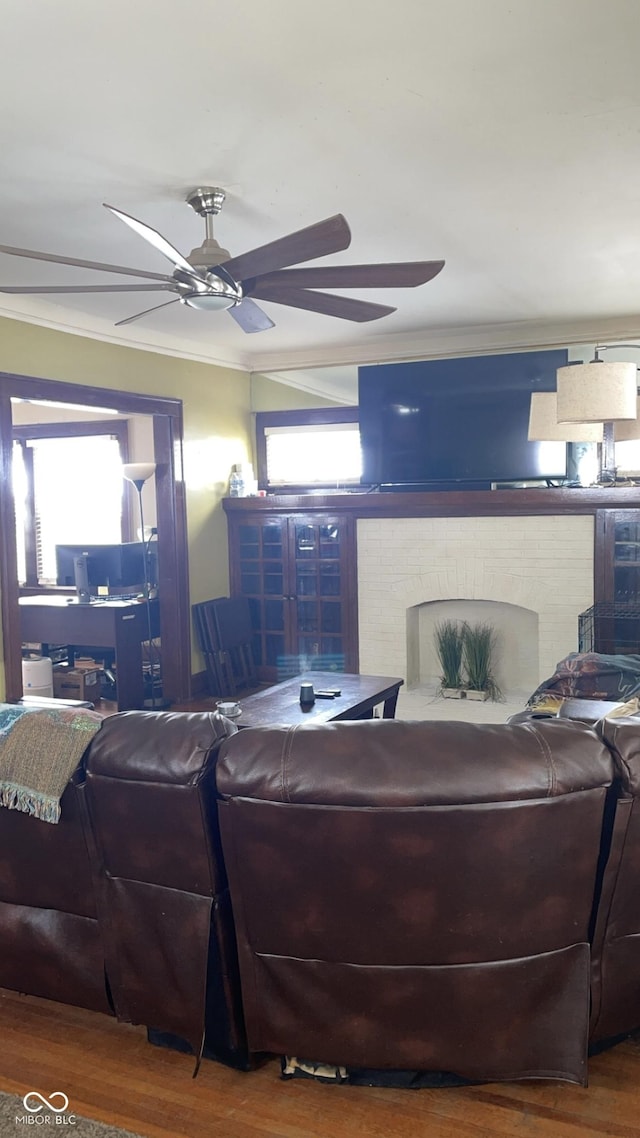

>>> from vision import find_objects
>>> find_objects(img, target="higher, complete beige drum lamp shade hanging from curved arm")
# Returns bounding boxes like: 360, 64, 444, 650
556, 361, 638, 423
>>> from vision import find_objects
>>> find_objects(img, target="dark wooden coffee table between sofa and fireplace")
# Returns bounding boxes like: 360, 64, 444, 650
233, 671, 404, 727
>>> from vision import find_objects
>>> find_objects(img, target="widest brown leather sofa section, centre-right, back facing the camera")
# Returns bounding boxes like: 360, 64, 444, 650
216, 720, 614, 1083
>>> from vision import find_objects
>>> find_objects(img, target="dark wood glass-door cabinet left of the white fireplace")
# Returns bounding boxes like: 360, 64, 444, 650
224, 511, 358, 681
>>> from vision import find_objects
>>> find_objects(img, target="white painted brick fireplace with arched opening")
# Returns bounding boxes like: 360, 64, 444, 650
358, 514, 593, 691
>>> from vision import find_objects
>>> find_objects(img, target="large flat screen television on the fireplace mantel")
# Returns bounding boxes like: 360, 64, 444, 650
358, 351, 568, 489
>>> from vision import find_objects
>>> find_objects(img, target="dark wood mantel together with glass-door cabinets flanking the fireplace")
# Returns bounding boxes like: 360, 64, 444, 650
224, 487, 640, 681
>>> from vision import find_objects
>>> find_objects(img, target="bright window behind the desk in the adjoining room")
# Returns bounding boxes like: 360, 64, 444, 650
13, 422, 129, 587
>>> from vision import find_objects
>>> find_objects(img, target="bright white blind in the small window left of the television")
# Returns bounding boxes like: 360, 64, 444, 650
264, 423, 362, 486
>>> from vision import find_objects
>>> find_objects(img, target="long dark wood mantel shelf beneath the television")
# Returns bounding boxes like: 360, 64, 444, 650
223, 486, 640, 518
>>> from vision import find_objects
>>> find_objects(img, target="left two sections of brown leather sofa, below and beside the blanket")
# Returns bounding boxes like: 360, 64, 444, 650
0, 711, 247, 1067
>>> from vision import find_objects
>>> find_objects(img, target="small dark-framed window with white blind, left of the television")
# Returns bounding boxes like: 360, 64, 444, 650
256, 407, 362, 489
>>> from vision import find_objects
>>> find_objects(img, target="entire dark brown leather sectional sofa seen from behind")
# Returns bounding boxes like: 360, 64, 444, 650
0, 711, 640, 1082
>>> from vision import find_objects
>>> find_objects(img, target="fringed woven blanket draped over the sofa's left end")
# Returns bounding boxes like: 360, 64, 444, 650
0, 708, 102, 823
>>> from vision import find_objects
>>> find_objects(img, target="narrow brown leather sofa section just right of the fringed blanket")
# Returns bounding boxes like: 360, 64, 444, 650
87, 711, 247, 1067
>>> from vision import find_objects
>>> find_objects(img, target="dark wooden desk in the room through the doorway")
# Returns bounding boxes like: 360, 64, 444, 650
19, 596, 148, 711
